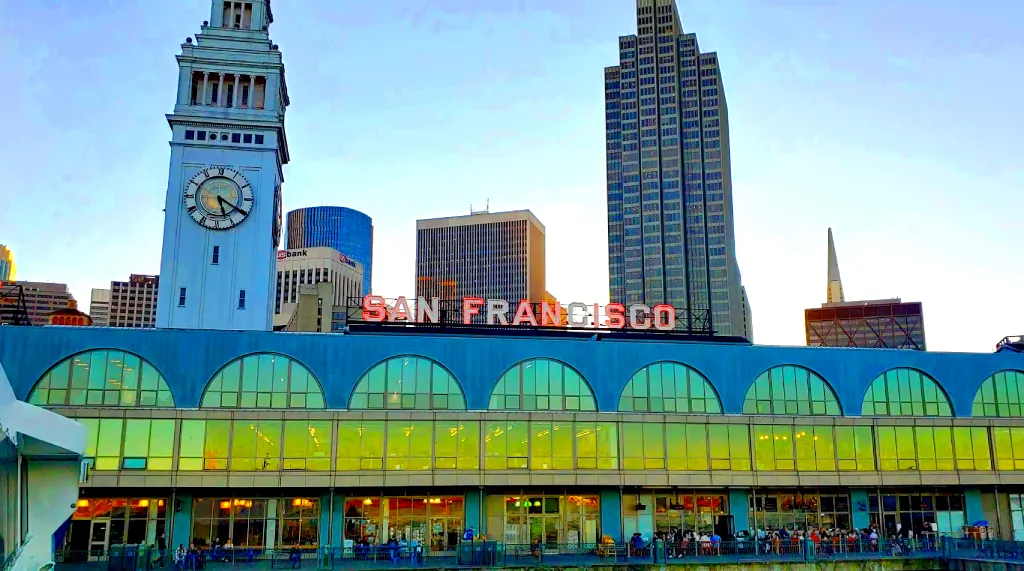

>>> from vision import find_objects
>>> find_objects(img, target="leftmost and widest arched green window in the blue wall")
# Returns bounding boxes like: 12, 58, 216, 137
29, 349, 174, 406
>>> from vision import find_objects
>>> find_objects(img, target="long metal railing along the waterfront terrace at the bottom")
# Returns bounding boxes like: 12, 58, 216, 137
55, 536, 1024, 571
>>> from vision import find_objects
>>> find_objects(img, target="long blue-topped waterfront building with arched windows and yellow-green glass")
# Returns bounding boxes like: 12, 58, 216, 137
0, 326, 1024, 552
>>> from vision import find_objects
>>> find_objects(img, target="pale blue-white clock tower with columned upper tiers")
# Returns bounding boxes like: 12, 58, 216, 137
157, 0, 289, 331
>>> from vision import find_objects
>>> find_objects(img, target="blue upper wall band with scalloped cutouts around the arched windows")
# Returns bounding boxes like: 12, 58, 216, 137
0, 326, 1024, 416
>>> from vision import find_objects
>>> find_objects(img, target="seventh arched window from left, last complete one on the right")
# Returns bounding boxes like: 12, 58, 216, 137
860, 368, 953, 416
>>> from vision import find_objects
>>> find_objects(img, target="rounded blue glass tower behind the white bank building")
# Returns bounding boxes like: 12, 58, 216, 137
287, 207, 374, 295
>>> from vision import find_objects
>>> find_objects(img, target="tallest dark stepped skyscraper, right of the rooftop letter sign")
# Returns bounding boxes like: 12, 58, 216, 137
604, 0, 752, 339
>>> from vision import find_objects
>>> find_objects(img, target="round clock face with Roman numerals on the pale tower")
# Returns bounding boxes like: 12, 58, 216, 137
184, 167, 254, 230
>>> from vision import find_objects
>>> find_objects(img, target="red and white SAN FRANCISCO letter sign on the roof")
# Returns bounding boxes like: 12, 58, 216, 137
360, 296, 676, 331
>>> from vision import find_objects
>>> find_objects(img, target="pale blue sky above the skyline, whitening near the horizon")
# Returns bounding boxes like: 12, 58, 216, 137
0, 0, 1024, 352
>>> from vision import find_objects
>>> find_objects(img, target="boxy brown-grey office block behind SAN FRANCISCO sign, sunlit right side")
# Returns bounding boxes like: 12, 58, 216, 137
416, 210, 550, 303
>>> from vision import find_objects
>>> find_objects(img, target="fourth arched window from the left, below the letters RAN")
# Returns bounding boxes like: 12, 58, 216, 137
487, 359, 597, 410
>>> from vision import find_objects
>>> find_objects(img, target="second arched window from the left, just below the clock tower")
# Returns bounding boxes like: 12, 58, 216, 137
202, 353, 325, 408
